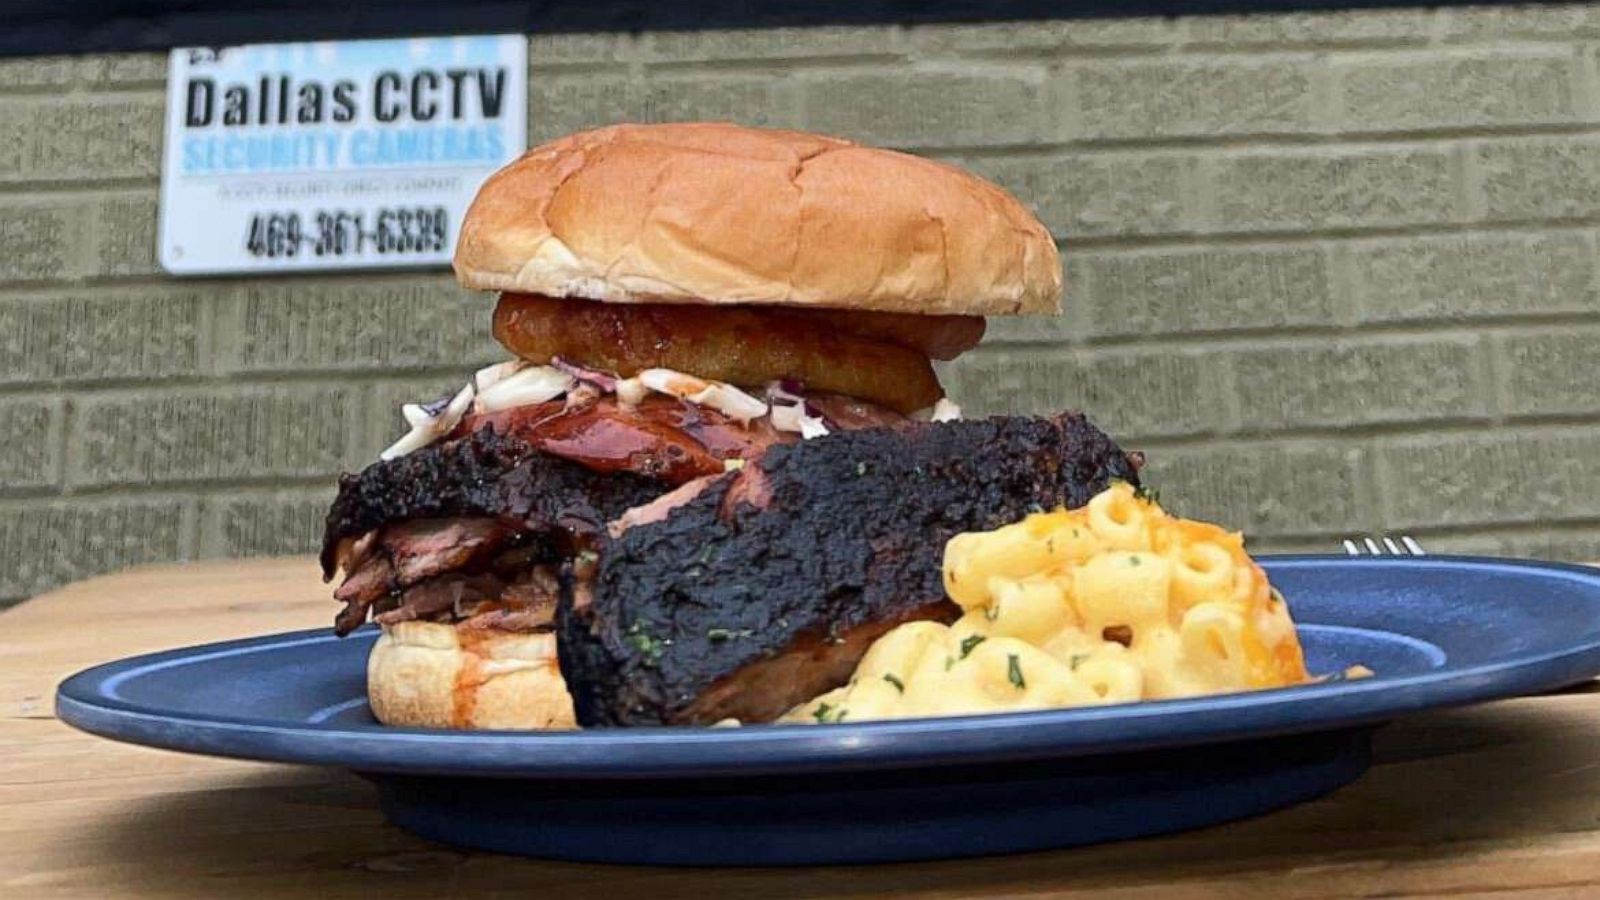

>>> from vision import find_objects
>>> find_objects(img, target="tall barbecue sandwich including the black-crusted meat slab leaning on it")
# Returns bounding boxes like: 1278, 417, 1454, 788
322, 123, 1138, 729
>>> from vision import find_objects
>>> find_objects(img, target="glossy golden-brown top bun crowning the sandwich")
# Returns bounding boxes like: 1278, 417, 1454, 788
456, 123, 1061, 315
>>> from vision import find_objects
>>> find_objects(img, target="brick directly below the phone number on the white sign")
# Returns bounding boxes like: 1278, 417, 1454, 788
222, 277, 506, 372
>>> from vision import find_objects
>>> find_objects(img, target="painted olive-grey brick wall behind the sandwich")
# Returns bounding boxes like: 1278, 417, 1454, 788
0, 5, 1600, 602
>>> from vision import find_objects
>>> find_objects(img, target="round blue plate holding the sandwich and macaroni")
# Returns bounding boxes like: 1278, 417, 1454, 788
56, 557, 1600, 865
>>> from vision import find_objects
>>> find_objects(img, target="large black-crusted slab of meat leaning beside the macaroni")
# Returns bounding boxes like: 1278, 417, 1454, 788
557, 413, 1138, 727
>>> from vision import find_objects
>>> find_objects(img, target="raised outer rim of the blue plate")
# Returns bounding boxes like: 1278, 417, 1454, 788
56, 554, 1600, 778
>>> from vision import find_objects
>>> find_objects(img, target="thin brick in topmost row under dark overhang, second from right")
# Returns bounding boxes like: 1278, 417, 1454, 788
1178, 10, 1434, 48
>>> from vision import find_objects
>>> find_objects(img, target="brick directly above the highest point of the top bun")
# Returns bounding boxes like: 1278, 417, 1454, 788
634, 74, 797, 127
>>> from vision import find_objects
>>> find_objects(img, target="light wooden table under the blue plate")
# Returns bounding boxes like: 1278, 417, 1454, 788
0, 559, 1600, 900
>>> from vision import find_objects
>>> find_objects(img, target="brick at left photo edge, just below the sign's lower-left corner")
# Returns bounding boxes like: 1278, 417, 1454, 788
0, 287, 205, 384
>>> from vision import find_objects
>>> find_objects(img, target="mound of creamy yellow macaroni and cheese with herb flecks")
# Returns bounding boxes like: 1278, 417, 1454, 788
784, 482, 1309, 722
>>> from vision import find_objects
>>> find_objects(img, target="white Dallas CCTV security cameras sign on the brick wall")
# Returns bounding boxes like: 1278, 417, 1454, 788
160, 35, 528, 274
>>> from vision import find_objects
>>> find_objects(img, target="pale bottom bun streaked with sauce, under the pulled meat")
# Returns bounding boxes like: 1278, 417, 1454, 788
366, 621, 576, 729
